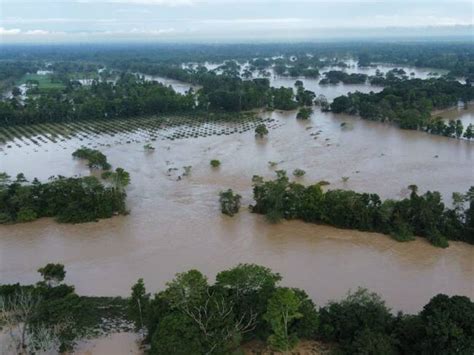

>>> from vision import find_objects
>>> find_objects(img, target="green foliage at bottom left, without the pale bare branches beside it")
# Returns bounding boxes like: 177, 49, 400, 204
0, 263, 128, 352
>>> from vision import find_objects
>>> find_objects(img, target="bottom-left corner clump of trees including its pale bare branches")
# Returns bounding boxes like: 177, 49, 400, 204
0, 264, 128, 355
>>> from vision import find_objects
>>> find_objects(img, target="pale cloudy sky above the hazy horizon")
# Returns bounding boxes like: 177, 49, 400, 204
0, 0, 474, 43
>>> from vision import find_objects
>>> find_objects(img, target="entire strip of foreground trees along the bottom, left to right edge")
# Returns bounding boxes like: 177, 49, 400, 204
0, 264, 474, 354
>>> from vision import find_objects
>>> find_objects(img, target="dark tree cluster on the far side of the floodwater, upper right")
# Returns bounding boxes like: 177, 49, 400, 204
330, 78, 474, 129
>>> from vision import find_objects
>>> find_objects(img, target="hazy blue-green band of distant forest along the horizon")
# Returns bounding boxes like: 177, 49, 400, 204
0, 40, 474, 78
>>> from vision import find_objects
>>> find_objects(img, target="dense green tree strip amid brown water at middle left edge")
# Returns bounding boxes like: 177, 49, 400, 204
0, 168, 129, 224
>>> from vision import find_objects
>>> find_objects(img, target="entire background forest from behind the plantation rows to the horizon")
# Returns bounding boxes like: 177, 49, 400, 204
0, 43, 474, 134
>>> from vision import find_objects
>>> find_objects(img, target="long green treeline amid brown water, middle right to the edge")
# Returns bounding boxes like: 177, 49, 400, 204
251, 171, 474, 247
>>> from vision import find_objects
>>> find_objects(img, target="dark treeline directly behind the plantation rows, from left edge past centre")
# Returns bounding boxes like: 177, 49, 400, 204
0, 67, 304, 126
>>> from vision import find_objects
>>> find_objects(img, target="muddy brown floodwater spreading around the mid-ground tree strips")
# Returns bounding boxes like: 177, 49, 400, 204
0, 106, 474, 318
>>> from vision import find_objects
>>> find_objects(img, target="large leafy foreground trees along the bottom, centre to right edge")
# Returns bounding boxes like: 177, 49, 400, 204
129, 264, 474, 354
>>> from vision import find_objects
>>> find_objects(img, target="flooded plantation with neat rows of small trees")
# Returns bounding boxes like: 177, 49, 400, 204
0, 114, 271, 149
